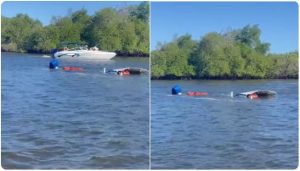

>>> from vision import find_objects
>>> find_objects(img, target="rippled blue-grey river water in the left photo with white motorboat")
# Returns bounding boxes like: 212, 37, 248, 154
1, 53, 149, 169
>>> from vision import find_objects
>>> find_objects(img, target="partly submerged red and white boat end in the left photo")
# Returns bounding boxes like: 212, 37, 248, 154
103, 67, 148, 76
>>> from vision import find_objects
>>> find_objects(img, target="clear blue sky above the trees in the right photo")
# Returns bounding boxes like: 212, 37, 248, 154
151, 2, 298, 53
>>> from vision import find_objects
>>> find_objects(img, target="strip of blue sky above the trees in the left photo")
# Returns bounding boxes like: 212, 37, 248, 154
1, 1, 140, 25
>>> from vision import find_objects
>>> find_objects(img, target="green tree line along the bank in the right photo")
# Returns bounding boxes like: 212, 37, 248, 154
151, 25, 298, 79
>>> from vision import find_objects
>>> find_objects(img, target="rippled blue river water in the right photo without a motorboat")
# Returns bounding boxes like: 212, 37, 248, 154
151, 80, 298, 169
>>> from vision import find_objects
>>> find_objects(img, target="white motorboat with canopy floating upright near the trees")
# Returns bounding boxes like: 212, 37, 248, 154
54, 43, 117, 60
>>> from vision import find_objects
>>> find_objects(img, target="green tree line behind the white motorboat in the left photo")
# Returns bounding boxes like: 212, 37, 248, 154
1, 2, 149, 56
